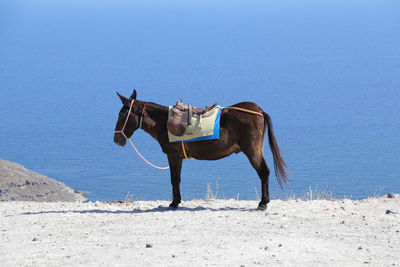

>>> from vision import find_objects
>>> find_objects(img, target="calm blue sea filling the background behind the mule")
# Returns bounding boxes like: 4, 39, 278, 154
0, 0, 400, 201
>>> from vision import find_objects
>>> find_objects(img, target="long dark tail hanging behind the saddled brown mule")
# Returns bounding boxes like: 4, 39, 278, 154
262, 111, 290, 189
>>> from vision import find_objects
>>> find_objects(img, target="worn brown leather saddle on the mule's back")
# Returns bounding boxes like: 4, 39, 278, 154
167, 98, 218, 136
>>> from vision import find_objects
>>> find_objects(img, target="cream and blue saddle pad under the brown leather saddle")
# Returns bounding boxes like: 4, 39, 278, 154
168, 106, 221, 143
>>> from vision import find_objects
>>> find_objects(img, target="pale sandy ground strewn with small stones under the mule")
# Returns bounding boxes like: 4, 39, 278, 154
0, 197, 400, 266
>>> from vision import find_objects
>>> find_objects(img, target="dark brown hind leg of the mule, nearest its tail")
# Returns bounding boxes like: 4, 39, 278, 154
244, 151, 270, 210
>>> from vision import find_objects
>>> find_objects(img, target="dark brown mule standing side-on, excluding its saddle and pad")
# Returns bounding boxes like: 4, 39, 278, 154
114, 90, 289, 210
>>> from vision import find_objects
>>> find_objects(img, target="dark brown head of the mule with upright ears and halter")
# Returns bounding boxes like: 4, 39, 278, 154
114, 90, 143, 146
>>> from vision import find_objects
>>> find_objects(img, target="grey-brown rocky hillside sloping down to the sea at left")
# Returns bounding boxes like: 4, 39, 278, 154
0, 159, 87, 202
